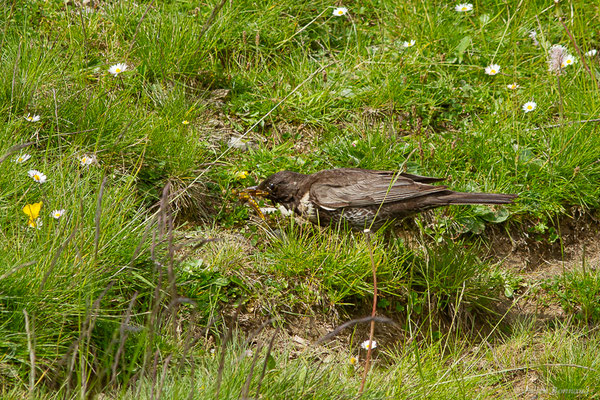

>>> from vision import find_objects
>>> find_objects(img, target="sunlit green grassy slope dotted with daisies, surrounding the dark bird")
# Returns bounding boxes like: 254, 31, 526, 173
0, 0, 600, 398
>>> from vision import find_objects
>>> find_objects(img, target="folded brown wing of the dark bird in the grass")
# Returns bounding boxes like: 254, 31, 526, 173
310, 173, 447, 209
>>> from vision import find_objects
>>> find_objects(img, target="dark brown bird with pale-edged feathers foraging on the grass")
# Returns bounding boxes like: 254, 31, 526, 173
246, 168, 517, 230
